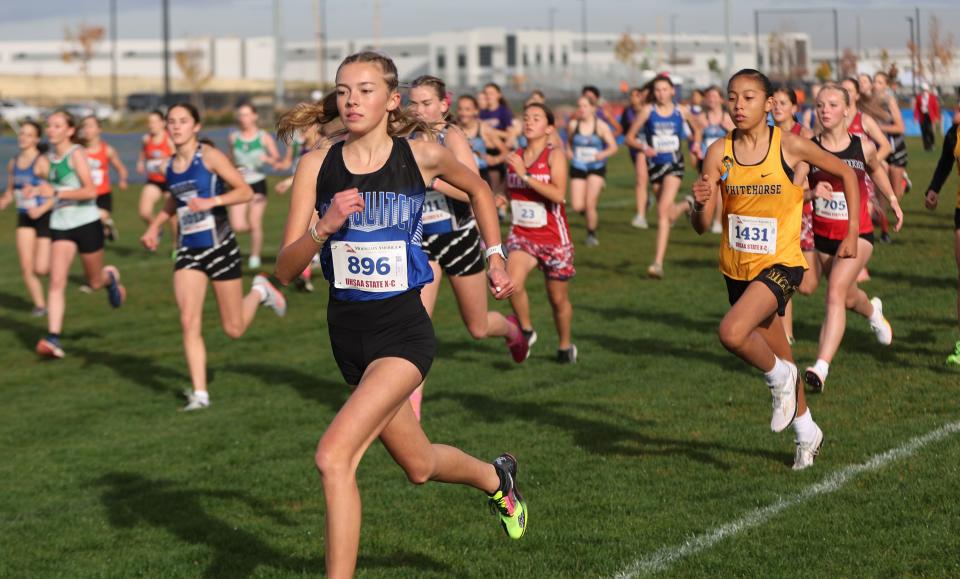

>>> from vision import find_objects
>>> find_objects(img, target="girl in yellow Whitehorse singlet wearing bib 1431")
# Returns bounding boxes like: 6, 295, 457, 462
691, 69, 859, 470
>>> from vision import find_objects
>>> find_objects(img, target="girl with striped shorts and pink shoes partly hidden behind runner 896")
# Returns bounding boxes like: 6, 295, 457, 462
408, 76, 530, 418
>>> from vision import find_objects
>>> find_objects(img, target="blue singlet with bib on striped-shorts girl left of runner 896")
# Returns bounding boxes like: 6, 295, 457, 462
166, 145, 230, 249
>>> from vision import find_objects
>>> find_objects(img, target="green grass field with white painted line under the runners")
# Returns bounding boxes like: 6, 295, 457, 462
0, 142, 960, 578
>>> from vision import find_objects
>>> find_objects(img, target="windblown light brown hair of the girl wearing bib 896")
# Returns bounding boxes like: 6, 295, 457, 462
277, 51, 433, 143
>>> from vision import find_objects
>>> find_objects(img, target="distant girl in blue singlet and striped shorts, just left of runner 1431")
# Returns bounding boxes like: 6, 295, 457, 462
626, 76, 700, 279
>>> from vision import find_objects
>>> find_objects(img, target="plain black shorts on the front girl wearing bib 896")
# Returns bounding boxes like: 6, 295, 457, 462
327, 290, 437, 386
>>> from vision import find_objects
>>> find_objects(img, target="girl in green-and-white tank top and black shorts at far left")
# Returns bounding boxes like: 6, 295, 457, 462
30, 111, 127, 358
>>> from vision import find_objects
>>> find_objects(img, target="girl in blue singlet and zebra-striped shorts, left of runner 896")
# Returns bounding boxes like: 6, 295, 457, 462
140, 103, 287, 410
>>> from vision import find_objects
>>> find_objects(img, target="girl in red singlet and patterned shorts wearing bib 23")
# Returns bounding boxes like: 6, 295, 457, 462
507, 103, 577, 363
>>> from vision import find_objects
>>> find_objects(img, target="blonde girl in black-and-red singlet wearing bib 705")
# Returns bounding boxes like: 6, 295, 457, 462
804, 83, 903, 392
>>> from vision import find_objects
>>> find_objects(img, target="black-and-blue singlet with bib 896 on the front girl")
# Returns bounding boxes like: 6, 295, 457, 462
316, 137, 433, 302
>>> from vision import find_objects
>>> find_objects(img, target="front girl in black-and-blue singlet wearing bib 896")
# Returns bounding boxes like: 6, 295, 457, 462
276, 52, 527, 578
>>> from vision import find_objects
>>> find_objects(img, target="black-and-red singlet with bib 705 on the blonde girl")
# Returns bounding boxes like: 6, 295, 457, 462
808, 135, 873, 239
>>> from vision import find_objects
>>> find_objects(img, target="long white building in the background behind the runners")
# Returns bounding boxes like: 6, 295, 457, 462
0, 28, 828, 95
